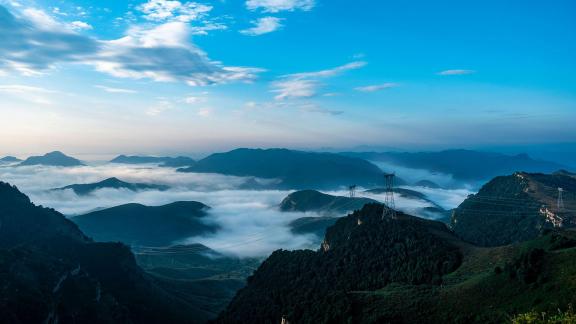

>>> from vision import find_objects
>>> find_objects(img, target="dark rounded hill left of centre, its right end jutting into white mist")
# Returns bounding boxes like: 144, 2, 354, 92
71, 201, 217, 246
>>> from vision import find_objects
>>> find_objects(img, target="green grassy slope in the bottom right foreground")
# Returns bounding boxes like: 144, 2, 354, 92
353, 231, 576, 323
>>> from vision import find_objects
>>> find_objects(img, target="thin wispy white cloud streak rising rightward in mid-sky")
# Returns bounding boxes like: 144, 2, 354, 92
271, 61, 366, 100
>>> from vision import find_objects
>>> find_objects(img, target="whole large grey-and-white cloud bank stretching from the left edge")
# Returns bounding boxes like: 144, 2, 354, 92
0, 5, 263, 86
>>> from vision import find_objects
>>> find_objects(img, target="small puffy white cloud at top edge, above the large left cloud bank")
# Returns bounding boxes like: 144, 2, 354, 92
137, 0, 212, 22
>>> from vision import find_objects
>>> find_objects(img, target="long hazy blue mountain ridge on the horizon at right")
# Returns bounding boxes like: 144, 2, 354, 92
344, 150, 566, 181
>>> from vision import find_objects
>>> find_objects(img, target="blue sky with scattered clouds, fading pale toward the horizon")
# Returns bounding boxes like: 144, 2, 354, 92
0, 0, 576, 156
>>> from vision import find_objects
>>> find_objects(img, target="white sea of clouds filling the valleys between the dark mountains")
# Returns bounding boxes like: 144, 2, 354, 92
0, 164, 471, 257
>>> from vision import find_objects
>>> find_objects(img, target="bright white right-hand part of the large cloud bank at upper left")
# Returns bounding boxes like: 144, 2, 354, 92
93, 21, 262, 86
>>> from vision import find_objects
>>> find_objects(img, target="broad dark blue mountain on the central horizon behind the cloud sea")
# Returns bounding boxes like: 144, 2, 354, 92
179, 149, 390, 189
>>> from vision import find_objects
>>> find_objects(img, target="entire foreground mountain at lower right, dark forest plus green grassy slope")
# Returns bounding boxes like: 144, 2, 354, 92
215, 204, 576, 324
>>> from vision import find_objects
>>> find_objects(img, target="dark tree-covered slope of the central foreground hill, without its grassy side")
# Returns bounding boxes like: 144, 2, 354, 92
218, 204, 461, 323
